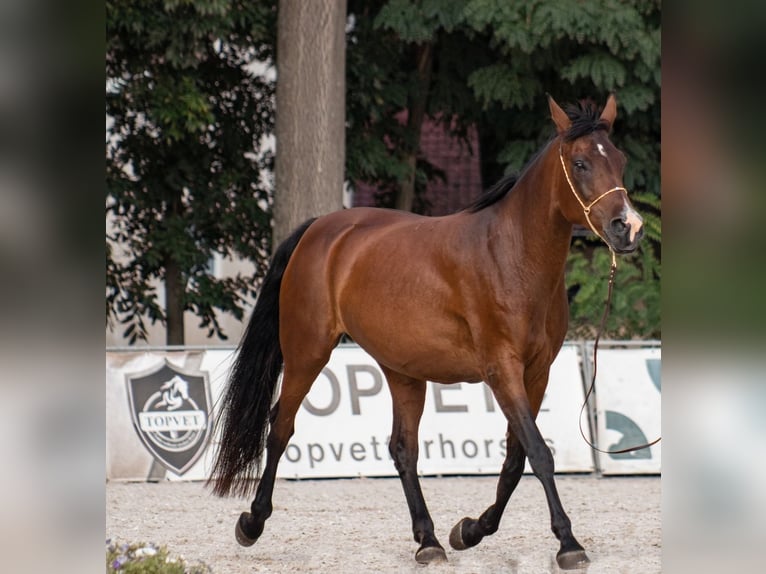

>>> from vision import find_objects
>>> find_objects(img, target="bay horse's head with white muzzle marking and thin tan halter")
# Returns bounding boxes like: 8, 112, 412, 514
548, 95, 644, 253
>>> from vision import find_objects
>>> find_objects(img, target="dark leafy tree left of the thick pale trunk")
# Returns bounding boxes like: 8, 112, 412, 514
106, 0, 276, 344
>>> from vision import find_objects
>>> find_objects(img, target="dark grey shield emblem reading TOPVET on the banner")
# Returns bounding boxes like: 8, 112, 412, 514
125, 359, 213, 475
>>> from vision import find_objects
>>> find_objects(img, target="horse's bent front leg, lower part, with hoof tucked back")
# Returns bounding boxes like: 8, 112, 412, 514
449, 427, 524, 550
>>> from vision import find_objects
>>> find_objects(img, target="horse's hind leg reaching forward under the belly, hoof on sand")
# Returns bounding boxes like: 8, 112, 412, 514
388, 367, 447, 564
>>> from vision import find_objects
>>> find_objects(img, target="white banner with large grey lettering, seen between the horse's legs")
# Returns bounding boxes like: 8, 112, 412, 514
278, 345, 594, 477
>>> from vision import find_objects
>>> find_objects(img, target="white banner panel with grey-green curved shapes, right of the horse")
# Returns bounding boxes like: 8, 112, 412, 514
591, 347, 662, 474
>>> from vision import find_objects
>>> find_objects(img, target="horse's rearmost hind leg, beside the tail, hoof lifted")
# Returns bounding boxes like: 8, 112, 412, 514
235, 358, 332, 546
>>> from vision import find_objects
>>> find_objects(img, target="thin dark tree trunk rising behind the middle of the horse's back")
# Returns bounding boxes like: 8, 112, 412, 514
396, 43, 433, 211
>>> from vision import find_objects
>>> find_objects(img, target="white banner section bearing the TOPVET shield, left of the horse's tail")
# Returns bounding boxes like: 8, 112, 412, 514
106, 350, 233, 481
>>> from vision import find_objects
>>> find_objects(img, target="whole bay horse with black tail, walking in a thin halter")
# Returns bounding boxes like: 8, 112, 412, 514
208, 95, 643, 569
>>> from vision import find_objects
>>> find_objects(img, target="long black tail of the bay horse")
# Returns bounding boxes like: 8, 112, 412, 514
208, 219, 314, 496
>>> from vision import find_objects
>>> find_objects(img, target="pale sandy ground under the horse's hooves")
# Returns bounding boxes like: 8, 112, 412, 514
106, 475, 662, 574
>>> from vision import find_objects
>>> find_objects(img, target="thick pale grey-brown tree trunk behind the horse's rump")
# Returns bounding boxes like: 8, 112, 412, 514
273, 0, 346, 249
